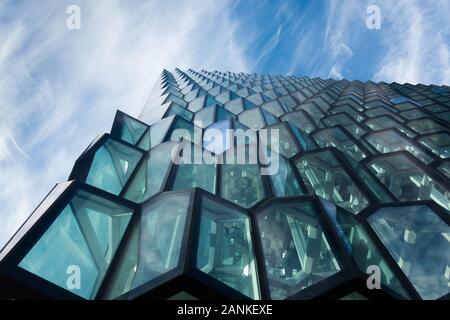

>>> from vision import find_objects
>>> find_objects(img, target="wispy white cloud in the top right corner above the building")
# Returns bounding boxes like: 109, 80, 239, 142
374, 0, 450, 84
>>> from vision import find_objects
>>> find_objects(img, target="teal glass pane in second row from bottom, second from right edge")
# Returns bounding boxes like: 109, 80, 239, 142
296, 151, 369, 214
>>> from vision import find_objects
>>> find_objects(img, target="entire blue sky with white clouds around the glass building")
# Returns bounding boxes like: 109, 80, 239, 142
0, 0, 450, 245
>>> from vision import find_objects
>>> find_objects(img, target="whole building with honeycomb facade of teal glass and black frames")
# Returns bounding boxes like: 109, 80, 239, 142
0, 69, 450, 300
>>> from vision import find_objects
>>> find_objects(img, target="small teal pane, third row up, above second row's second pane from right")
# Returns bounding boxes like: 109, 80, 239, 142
313, 127, 367, 161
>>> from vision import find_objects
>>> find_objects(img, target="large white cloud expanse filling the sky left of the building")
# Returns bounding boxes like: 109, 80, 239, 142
0, 0, 249, 246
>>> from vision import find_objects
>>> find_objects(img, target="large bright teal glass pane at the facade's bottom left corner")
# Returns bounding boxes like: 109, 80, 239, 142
19, 191, 133, 299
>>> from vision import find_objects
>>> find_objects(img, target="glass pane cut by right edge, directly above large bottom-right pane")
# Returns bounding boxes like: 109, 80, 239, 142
369, 154, 450, 210
